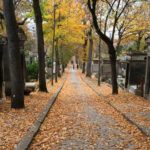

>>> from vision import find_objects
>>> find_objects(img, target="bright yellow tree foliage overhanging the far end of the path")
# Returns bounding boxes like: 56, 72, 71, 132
43, 0, 85, 84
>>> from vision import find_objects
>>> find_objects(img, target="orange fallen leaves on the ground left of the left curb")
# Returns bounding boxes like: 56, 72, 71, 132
0, 78, 64, 150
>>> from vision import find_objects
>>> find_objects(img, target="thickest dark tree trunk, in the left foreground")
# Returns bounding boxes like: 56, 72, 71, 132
3, 0, 24, 108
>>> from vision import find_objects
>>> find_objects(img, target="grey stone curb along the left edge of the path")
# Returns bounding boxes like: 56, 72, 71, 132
15, 81, 65, 150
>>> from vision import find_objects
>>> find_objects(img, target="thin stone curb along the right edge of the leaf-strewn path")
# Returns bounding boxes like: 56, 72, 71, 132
81, 77, 150, 137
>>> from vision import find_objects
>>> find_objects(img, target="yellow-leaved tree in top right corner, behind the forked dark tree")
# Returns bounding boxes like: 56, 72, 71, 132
116, 0, 150, 52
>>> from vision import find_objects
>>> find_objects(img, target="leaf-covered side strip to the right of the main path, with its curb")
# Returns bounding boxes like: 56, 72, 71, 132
81, 75, 150, 137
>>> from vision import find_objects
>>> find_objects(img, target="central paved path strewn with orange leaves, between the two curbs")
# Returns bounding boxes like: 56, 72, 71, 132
30, 70, 150, 150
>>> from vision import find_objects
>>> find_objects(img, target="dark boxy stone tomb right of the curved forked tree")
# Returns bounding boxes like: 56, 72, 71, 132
125, 52, 147, 96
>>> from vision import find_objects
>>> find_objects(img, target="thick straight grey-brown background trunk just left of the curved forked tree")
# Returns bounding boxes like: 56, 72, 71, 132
86, 29, 93, 77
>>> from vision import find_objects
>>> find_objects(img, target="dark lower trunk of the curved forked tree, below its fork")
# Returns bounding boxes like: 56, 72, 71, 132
109, 44, 118, 94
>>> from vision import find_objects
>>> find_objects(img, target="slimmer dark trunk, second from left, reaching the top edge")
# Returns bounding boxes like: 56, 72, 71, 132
33, 0, 47, 92
